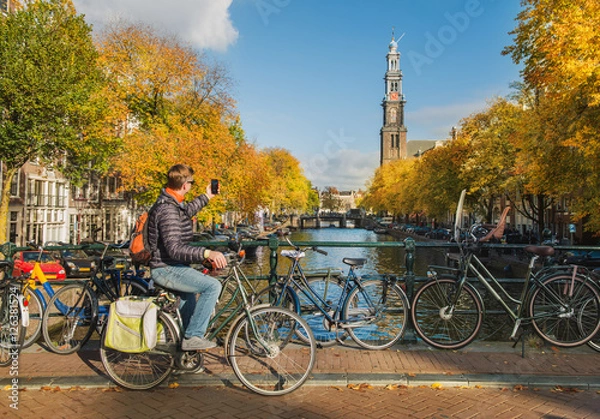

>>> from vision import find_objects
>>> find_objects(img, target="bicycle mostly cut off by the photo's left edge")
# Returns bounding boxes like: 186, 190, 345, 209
0, 260, 29, 367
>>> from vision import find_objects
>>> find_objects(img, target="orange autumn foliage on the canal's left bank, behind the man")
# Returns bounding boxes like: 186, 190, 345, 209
98, 22, 310, 221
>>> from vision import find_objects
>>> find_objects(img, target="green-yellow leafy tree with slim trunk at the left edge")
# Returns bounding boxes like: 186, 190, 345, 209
0, 0, 113, 242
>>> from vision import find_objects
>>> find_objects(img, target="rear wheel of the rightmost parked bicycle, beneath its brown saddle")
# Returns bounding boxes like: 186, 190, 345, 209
529, 274, 600, 348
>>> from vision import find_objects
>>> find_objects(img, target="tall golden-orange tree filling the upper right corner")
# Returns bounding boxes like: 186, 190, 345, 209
503, 0, 600, 231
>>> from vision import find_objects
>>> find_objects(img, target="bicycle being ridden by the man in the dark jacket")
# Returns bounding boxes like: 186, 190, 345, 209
100, 244, 316, 396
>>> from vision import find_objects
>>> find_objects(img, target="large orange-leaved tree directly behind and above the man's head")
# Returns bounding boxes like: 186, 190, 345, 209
98, 21, 241, 208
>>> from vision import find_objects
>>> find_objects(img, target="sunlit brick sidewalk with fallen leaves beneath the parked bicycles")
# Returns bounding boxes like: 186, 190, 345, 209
0, 341, 600, 389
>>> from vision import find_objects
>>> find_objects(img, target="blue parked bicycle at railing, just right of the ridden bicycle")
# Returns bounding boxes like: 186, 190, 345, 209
258, 237, 409, 350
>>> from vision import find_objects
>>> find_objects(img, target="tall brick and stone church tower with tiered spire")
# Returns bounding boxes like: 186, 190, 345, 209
379, 32, 407, 165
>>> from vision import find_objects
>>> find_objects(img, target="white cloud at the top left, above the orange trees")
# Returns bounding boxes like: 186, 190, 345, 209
73, 0, 238, 51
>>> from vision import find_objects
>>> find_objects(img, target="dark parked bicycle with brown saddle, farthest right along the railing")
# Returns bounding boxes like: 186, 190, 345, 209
411, 191, 600, 349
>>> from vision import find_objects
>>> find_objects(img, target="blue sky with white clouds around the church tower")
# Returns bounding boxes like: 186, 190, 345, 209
74, 0, 520, 189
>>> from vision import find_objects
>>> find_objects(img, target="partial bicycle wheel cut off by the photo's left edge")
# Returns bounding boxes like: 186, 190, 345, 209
0, 283, 26, 367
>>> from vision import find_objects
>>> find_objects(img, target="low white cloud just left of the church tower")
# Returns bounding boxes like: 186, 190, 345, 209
301, 148, 379, 190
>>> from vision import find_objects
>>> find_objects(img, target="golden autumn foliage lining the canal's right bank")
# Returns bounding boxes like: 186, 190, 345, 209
363, 0, 600, 236
